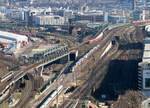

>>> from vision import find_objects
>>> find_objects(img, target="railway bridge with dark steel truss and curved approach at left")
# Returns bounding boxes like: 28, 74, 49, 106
0, 46, 78, 100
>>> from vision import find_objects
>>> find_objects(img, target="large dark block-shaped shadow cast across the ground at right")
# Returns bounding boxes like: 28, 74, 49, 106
92, 60, 138, 101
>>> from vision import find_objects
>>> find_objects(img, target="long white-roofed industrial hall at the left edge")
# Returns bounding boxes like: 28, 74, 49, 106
0, 31, 28, 49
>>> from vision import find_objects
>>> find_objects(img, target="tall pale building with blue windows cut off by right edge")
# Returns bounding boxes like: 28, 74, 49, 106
138, 37, 150, 96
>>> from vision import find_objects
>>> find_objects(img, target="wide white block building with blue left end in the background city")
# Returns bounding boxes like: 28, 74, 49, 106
34, 15, 65, 25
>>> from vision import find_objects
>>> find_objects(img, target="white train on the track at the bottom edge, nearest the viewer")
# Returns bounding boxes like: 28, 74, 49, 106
39, 85, 63, 108
